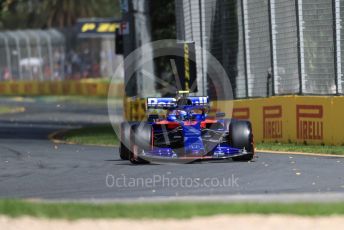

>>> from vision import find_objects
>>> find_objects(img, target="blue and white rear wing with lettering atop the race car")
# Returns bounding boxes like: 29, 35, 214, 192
147, 96, 209, 109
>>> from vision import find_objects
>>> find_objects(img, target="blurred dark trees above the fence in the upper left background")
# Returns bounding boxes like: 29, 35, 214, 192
0, 0, 120, 29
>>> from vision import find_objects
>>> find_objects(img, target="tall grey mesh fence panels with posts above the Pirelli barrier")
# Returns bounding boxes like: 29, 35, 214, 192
176, 0, 344, 98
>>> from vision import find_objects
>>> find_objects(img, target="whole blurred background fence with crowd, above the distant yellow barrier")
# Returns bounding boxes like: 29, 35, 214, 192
0, 28, 123, 81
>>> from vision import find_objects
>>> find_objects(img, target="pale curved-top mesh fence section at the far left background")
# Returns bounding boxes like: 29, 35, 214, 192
0, 29, 65, 81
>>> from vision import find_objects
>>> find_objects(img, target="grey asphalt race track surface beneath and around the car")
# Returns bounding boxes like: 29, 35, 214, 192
0, 99, 344, 200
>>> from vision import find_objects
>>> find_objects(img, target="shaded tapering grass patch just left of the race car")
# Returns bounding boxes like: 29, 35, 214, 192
61, 125, 119, 146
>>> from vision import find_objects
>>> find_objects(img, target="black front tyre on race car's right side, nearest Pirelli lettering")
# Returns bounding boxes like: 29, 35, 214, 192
227, 120, 254, 161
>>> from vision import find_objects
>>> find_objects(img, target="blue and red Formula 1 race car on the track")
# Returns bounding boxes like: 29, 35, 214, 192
119, 92, 254, 164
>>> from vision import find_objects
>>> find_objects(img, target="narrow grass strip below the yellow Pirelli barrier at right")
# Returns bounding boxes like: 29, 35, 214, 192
256, 143, 344, 155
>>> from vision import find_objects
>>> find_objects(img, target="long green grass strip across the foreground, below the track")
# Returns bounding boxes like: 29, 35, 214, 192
0, 200, 344, 219
